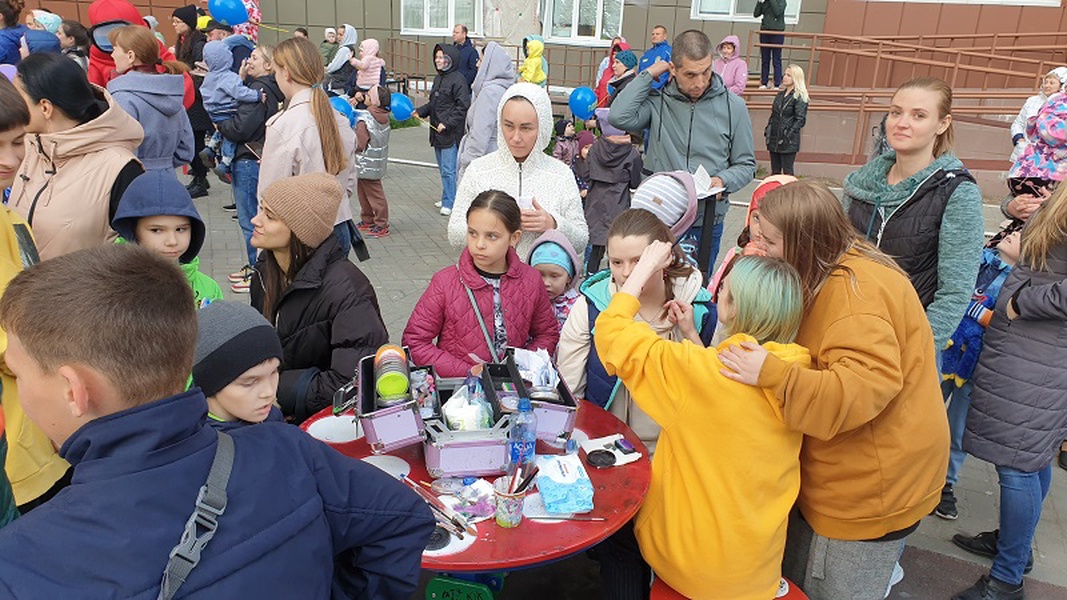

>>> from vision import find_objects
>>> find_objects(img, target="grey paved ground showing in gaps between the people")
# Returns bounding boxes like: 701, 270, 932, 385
196, 128, 1067, 600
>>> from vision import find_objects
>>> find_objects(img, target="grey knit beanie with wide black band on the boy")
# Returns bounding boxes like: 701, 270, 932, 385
193, 301, 282, 396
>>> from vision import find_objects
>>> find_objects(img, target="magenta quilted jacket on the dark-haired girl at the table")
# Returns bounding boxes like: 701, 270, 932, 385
403, 249, 559, 377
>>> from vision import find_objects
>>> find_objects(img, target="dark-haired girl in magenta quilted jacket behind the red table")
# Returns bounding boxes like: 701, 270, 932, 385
403, 190, 559, 377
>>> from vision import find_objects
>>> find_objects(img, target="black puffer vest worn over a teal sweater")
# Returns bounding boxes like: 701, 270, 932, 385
848, 169, 974, 309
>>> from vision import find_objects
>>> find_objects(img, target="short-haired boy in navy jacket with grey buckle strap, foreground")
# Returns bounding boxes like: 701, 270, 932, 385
0, 246, 433, 600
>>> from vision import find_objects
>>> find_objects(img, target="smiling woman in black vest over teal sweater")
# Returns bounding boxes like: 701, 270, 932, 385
844, 78, 985, 358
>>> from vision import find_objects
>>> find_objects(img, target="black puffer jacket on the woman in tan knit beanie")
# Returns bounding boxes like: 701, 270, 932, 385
251, 235, 389, 424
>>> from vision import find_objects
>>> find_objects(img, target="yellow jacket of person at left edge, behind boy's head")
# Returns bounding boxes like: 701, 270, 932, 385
0, 206, 69, 505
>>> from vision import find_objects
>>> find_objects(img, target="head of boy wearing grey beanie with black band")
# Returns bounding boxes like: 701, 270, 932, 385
193, 301, 283, 431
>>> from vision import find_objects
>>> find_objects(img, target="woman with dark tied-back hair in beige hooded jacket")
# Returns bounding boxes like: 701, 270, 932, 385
7, 53, 144, 260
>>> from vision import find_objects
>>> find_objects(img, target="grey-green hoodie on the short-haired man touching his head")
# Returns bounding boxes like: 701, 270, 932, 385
608, 72, 755, 200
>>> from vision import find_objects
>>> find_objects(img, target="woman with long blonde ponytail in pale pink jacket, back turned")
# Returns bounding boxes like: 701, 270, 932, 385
258, 37, 355, 255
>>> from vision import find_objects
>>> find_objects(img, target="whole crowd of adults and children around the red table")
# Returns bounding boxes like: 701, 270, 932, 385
0, 0, 1067, 600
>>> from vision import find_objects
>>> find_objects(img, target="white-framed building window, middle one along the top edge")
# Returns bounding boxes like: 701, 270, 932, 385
544, 0, 622, 47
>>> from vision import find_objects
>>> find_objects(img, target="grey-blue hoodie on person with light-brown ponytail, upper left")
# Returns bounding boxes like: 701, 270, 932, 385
108, 70, 193, 169
